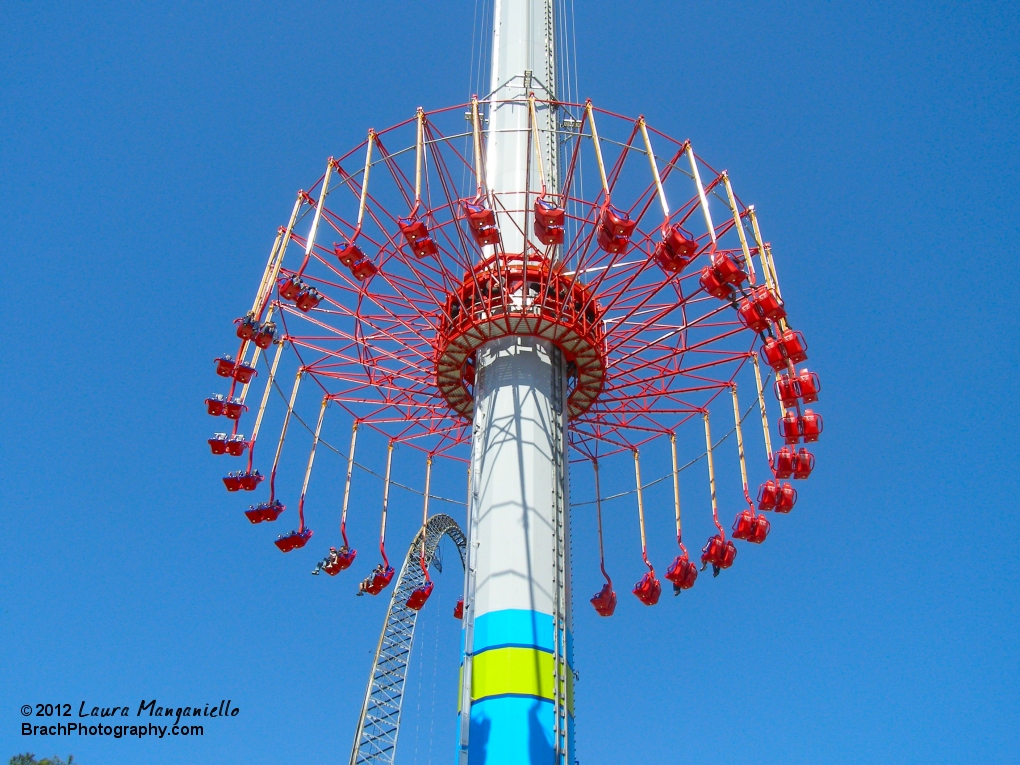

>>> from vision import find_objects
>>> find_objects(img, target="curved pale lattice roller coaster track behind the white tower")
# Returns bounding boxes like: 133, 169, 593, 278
351, 515, 467, 765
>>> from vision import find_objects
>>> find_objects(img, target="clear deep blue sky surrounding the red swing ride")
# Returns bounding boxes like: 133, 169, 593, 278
0, 0, 1020, 765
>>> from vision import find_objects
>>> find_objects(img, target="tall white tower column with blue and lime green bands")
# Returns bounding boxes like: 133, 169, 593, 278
460, 0, 572, 765
